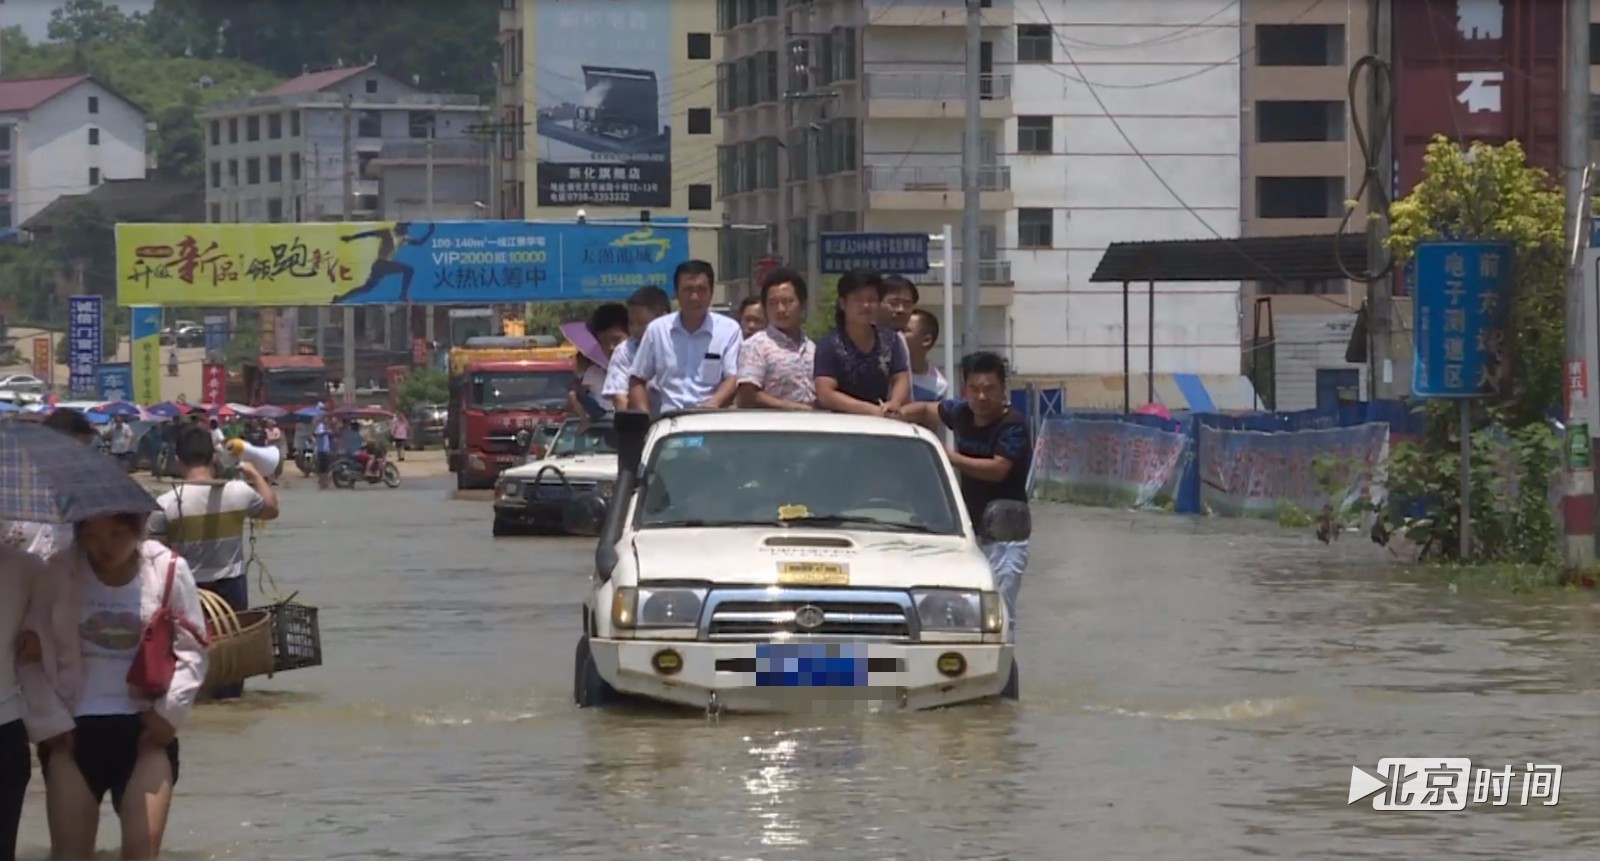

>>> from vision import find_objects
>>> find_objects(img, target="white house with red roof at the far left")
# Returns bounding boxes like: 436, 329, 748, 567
0, 75, 146, 230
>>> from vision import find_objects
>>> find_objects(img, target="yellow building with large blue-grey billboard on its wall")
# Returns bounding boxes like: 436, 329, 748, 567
501, 0, 723, 275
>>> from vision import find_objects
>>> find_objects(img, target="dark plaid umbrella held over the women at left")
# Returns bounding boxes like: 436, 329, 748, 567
0, 424, 155, 523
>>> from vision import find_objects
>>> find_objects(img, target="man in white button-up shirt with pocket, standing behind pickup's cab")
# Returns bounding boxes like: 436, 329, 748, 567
627, 261, 742, 414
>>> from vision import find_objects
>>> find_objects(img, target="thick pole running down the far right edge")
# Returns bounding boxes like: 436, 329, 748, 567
1562, 0, 1597, 570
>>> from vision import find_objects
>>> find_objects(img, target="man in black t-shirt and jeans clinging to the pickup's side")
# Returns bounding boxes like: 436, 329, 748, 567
901, 352, 1034, 634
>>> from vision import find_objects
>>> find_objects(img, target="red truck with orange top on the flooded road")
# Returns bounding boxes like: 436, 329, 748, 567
445, 338, 576, 490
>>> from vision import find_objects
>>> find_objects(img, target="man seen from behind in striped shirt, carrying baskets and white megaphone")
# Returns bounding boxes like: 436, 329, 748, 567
149, 427, 278, 699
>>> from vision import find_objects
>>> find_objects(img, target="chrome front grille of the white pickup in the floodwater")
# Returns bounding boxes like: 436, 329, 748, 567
701, 589, 917, 640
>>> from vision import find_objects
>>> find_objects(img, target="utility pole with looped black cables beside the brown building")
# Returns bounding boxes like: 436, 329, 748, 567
1366, 0, 1411, 400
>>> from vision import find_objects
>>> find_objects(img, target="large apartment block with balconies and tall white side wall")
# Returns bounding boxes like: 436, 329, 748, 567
718, 0, 1240, 378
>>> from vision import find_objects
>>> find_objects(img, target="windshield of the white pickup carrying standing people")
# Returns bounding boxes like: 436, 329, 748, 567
638, 431, 962, 535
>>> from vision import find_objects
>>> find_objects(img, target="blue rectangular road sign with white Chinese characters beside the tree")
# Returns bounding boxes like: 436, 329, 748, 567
1411, 242, 1512, 397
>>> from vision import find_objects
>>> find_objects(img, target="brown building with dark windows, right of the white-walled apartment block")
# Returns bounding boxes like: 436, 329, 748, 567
1240, 0, 1368, 410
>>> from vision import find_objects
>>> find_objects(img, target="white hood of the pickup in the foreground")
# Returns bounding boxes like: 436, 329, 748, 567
632, 527, 994, 589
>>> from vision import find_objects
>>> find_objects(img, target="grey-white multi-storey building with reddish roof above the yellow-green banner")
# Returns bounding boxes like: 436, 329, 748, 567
200, 64, 488, 222
